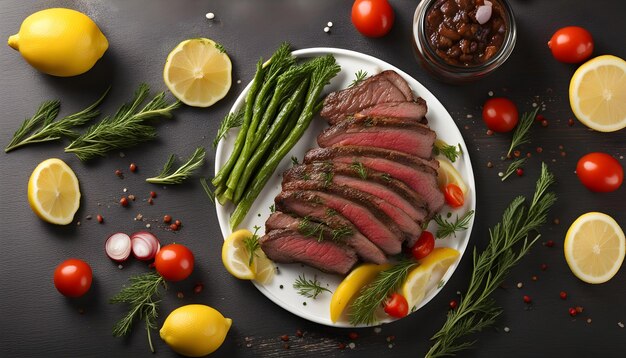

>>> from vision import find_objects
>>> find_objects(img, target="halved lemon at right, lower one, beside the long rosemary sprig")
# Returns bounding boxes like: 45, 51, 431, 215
563, 212, 626, 283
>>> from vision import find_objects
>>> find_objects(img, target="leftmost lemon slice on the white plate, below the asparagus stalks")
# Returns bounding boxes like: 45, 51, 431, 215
222, 229, 257, 280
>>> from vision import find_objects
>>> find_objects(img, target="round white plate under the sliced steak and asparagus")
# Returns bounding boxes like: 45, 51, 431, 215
215, 48, 476, 327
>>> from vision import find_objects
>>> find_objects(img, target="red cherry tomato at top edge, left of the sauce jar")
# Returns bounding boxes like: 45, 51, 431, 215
352, 0, 395, 37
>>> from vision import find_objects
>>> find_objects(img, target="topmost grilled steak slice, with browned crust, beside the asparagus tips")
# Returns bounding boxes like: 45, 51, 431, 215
320, 73, 412, 124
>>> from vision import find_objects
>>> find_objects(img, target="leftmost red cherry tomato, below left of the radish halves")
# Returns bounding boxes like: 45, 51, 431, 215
54, 259, 93, 297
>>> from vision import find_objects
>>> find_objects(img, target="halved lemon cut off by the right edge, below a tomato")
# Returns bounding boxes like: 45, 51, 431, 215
569, 55, 626, 132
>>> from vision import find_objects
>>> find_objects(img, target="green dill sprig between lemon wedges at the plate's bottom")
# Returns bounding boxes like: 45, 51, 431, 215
350, 260, 418, 326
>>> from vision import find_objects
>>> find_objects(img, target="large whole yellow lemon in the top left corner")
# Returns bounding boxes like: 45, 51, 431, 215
9, 8, 109, 77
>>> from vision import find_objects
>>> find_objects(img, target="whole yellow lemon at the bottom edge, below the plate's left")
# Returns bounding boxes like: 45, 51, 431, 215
159, 304, 232, 357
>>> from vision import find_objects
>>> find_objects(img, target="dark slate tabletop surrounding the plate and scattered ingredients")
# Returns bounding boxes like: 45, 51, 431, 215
0, 0, 626, 357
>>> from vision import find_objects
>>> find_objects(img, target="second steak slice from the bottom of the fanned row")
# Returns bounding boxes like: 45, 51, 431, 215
265, 210, 387, 264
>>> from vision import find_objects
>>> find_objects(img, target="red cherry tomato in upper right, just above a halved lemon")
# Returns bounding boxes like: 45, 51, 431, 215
548, 26, 593, 63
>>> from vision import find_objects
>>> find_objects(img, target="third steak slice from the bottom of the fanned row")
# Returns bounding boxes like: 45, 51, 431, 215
275, 190, 402, 255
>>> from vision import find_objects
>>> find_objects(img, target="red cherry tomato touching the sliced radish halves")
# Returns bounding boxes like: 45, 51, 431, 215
154, 244, 194, 281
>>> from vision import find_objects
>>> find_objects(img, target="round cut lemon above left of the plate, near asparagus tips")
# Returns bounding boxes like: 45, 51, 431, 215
163, 38, 232, 107
